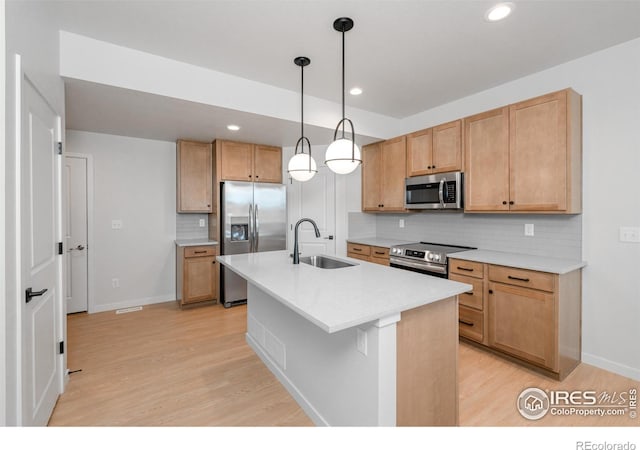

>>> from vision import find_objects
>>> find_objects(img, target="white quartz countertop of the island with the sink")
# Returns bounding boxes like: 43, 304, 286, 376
218, 251, 472, 333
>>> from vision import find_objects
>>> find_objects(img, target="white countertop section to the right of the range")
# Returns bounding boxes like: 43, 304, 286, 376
450, 250, 587, 275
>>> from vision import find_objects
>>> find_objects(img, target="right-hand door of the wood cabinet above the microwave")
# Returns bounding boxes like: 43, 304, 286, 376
431, 120, 462, 173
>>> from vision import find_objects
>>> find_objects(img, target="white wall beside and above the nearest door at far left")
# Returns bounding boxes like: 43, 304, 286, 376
0, 1, 64, 425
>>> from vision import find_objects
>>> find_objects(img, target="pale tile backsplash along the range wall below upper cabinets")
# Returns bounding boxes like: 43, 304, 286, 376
349, 211, 582, 259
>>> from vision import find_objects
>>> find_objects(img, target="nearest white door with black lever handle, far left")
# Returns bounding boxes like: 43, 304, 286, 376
20, 78, 63, 426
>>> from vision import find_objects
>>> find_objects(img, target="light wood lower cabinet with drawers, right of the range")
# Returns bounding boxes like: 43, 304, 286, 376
449, 258, 582, 380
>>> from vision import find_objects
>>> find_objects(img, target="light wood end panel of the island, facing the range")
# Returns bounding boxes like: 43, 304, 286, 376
396, 297, 458, 426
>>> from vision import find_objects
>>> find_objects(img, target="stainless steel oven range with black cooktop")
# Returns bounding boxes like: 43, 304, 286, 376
389, 242, 475, 278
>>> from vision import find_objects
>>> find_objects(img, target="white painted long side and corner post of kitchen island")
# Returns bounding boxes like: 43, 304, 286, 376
247, 283, 396, 426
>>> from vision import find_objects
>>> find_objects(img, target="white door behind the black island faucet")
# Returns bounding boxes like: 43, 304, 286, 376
288, 165, 336, 256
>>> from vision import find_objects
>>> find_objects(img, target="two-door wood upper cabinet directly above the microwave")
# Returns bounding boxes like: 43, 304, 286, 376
407, 120, 462, 177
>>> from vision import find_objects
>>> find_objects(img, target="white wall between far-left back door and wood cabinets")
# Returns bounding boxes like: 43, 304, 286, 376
67, 130, 176, 312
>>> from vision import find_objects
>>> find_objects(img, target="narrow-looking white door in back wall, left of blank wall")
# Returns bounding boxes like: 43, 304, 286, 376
65, 155, 89, 314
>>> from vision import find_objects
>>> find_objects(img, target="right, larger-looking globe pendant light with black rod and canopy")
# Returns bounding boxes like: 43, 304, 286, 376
325, 17, 362, 174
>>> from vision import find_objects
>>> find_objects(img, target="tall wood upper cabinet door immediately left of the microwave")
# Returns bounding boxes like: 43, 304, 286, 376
381, 136, 407, 211
